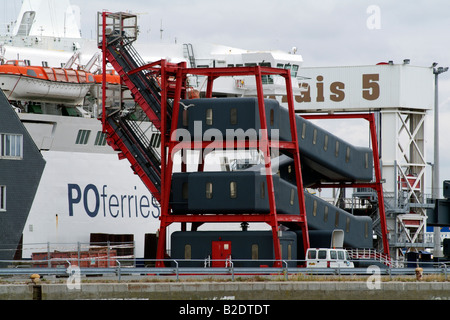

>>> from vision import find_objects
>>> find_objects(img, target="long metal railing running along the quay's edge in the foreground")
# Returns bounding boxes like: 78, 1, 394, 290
0, 259, 450, 282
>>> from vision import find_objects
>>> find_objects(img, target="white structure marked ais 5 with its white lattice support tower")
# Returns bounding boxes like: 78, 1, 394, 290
288, 60, 445, 260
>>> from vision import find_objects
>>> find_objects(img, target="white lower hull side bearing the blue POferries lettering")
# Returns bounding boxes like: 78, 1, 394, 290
23, 151, 164, 258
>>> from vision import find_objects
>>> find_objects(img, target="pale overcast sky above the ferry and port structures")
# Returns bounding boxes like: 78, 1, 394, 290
2, 0, 450, 192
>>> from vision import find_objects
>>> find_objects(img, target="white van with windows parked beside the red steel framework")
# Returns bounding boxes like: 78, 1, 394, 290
306, 248, 355, 268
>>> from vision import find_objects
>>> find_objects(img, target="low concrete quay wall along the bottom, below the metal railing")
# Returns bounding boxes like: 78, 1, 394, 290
0, 281, 450, 300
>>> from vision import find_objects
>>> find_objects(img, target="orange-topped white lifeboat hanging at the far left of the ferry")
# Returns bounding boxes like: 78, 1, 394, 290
0, 60, 95, 105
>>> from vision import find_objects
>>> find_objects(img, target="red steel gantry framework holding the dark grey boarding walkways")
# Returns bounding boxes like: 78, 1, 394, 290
99, 12, 389, 266
